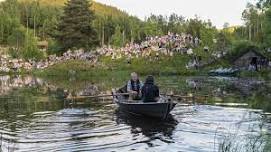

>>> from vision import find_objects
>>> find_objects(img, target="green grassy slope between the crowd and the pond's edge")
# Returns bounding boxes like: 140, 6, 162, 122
13, 55, 271, 80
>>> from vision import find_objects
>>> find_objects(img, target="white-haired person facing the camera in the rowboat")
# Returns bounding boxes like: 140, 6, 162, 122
127, 72, 143, 100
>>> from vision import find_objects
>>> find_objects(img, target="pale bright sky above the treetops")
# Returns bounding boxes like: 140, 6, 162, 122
96, 0, 255, 28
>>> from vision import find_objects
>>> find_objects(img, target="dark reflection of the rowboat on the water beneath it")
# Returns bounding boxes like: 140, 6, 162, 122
115, 109, 178, 143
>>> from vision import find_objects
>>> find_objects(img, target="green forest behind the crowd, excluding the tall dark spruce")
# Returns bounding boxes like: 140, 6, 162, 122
0, 0, 271, 59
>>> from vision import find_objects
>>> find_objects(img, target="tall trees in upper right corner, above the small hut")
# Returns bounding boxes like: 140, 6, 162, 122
234, 0, 271, 50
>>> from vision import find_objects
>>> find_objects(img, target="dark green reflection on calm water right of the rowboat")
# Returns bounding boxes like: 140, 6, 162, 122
162, 77, 271, 112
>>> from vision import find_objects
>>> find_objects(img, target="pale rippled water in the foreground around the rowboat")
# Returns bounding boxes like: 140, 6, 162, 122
0, 105, 270, 152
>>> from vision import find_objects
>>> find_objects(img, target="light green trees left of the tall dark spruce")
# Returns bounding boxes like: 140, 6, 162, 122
0, 0, 61, 59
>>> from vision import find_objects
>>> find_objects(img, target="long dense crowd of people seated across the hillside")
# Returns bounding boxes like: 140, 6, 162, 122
0, 33, 203, 73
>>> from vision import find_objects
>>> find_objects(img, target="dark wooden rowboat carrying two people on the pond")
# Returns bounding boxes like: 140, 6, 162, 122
113, 89, 176, 120
